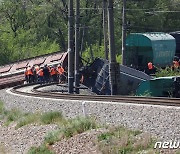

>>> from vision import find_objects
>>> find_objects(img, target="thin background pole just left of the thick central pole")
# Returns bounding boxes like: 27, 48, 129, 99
103, 0, 108, 60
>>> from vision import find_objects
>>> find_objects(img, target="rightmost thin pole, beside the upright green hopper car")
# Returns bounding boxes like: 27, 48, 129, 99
122, 0, 126, 65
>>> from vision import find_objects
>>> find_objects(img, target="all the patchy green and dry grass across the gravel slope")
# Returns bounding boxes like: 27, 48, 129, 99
0, 102, 166, 154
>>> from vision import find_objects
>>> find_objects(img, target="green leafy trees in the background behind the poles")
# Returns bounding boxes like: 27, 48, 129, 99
0, 0, 180, 65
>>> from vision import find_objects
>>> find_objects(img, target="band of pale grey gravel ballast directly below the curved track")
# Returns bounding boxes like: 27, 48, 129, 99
0, 90, 180, 153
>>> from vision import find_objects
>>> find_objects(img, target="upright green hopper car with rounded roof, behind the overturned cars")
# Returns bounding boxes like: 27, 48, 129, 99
125, 32, 176, 70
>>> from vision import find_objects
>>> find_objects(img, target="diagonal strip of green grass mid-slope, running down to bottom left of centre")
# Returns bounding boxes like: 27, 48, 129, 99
28, 117, 97, 154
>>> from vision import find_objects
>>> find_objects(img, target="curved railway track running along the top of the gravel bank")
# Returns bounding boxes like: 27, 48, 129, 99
11, 84, 180, 106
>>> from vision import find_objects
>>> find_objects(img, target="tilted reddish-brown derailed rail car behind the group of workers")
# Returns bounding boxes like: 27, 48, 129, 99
0, 51, 67, 89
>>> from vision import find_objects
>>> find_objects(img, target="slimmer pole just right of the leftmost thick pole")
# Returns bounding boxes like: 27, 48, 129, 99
75, 0, 80, 94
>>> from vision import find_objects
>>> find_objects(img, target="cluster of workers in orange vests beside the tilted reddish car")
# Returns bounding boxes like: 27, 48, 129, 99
24, 64, 66, 83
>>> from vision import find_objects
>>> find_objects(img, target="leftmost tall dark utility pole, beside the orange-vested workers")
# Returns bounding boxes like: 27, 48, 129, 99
68, 0, 74, 94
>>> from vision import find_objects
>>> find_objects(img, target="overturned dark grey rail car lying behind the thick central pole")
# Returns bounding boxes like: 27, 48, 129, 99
82, 58, 152, 95
